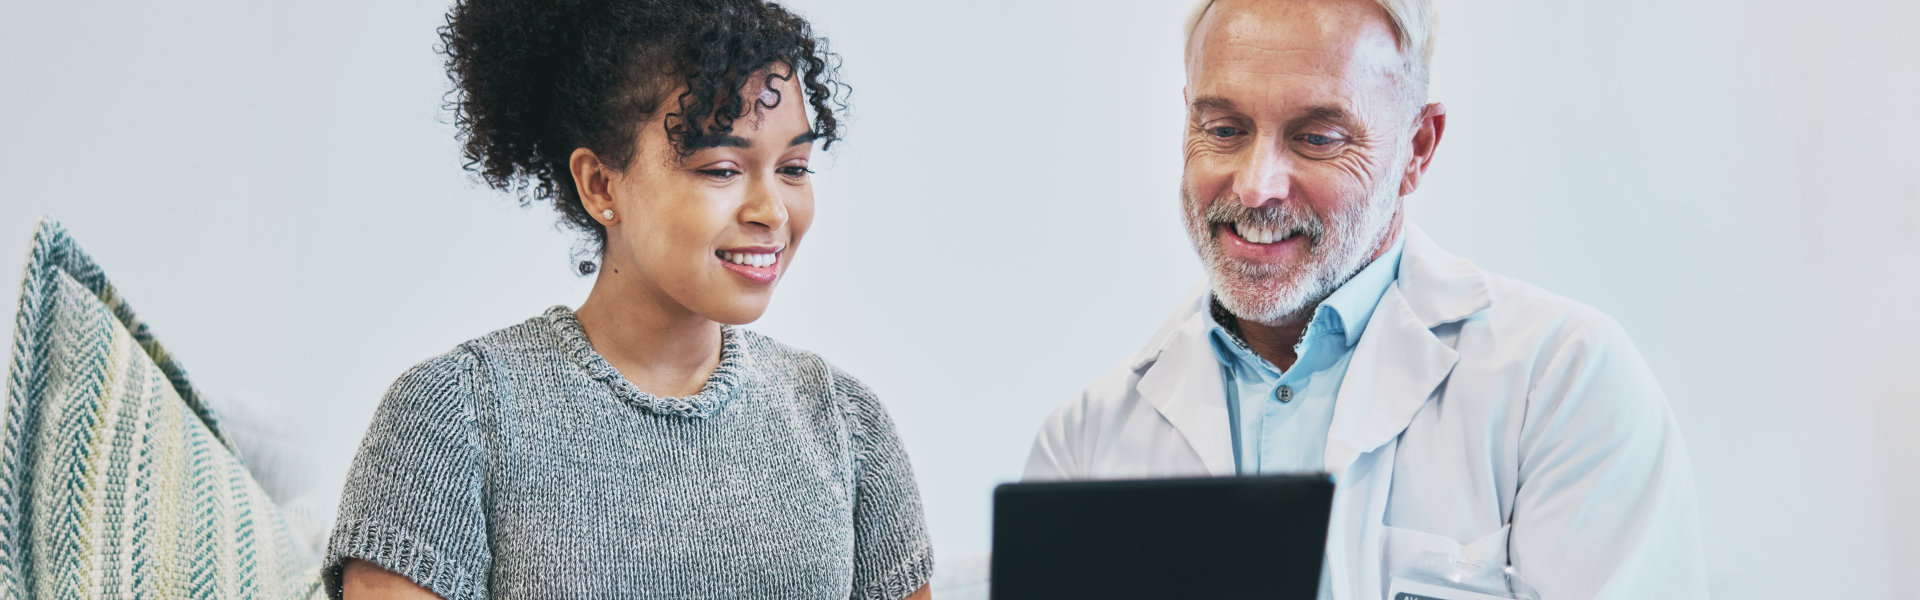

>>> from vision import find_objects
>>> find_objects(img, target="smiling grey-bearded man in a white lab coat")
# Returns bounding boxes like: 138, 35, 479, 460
1027, 0, 1707, 600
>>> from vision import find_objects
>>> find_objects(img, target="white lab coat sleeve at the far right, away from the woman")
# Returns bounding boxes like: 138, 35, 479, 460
1509, 312, 1707, 600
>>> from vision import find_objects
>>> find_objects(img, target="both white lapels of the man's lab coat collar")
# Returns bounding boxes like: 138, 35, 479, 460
1131, 223, 1492, 475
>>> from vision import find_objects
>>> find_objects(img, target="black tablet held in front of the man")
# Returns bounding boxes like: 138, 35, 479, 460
989, 475, 1332, 600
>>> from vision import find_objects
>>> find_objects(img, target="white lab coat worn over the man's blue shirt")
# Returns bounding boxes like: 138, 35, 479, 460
1025, 225, 1707, 600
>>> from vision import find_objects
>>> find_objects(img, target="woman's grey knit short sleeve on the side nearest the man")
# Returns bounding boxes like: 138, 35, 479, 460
833, 369, 933, 600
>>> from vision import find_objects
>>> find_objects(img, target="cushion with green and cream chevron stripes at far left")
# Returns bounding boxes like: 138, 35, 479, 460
0, 219, 324, 600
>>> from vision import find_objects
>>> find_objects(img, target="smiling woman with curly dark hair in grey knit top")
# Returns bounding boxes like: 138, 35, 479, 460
324, 0, 931, 600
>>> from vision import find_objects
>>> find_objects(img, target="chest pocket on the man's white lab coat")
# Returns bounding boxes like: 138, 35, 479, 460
1380, 525, 1538, 600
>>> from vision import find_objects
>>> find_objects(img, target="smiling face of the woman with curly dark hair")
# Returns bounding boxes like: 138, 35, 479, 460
588, 67, 814, 325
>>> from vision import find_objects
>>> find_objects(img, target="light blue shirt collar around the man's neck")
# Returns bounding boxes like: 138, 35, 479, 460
1208, 233, 1405, 373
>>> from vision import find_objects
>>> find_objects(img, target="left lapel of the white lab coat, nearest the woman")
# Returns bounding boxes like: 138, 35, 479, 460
1135, 312, 1235, 475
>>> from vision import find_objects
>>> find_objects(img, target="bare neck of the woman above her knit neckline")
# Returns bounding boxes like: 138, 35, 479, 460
574, 267, 720, 398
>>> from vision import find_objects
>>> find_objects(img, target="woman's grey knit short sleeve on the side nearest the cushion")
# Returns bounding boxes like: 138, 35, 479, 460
323, 350, 490, 600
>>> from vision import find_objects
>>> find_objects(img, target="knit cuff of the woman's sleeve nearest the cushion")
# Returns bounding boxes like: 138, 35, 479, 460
321, 519, 486, 600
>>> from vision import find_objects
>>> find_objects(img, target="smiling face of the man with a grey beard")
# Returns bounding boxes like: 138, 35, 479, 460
1181, 0, 1421, 325
